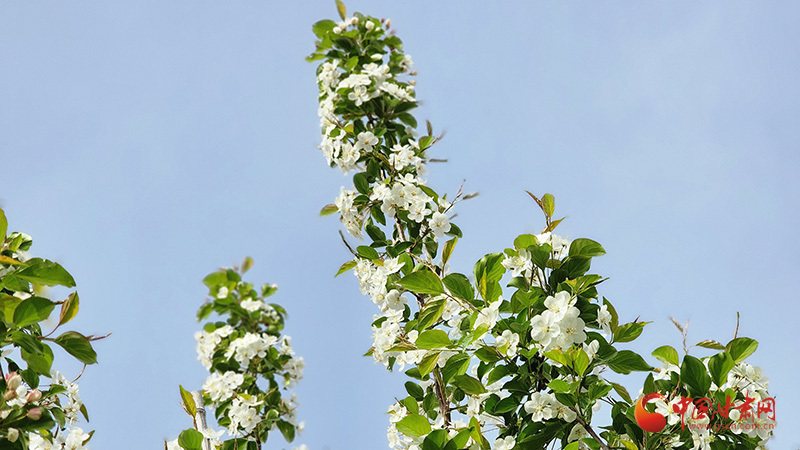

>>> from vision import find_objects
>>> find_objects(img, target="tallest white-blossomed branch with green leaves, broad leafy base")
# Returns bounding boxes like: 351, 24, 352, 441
308, 3, 766, 450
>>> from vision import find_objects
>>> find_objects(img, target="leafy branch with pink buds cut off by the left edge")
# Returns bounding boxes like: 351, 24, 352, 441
0, 209, 99, 449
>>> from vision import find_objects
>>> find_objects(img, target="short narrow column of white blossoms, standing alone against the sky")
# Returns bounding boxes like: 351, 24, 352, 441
167, 258, 305, 449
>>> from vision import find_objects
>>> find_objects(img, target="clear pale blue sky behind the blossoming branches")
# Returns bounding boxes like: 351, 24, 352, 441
0, 0, 800, 450
